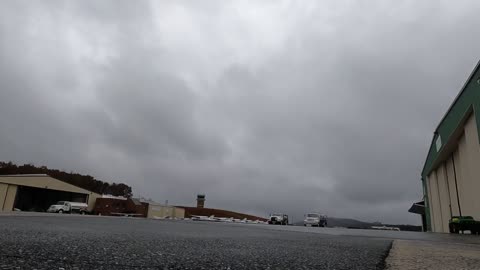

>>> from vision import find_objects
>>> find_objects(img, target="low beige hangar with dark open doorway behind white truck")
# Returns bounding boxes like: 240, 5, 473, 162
0, 174, 101, 212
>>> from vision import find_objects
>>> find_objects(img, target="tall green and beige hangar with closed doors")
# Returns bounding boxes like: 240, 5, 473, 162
422, 62, 480, 233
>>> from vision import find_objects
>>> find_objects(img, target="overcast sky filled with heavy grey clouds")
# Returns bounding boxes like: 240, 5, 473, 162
0, 0, 480, 224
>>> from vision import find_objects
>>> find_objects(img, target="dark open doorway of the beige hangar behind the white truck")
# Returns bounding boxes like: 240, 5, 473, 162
13, 186, 88, 212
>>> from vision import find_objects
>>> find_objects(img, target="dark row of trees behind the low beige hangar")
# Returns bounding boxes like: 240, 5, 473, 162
0, 161, 132, 197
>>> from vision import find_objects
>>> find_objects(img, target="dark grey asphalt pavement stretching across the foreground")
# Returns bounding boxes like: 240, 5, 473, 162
0, 215, 392, 269
